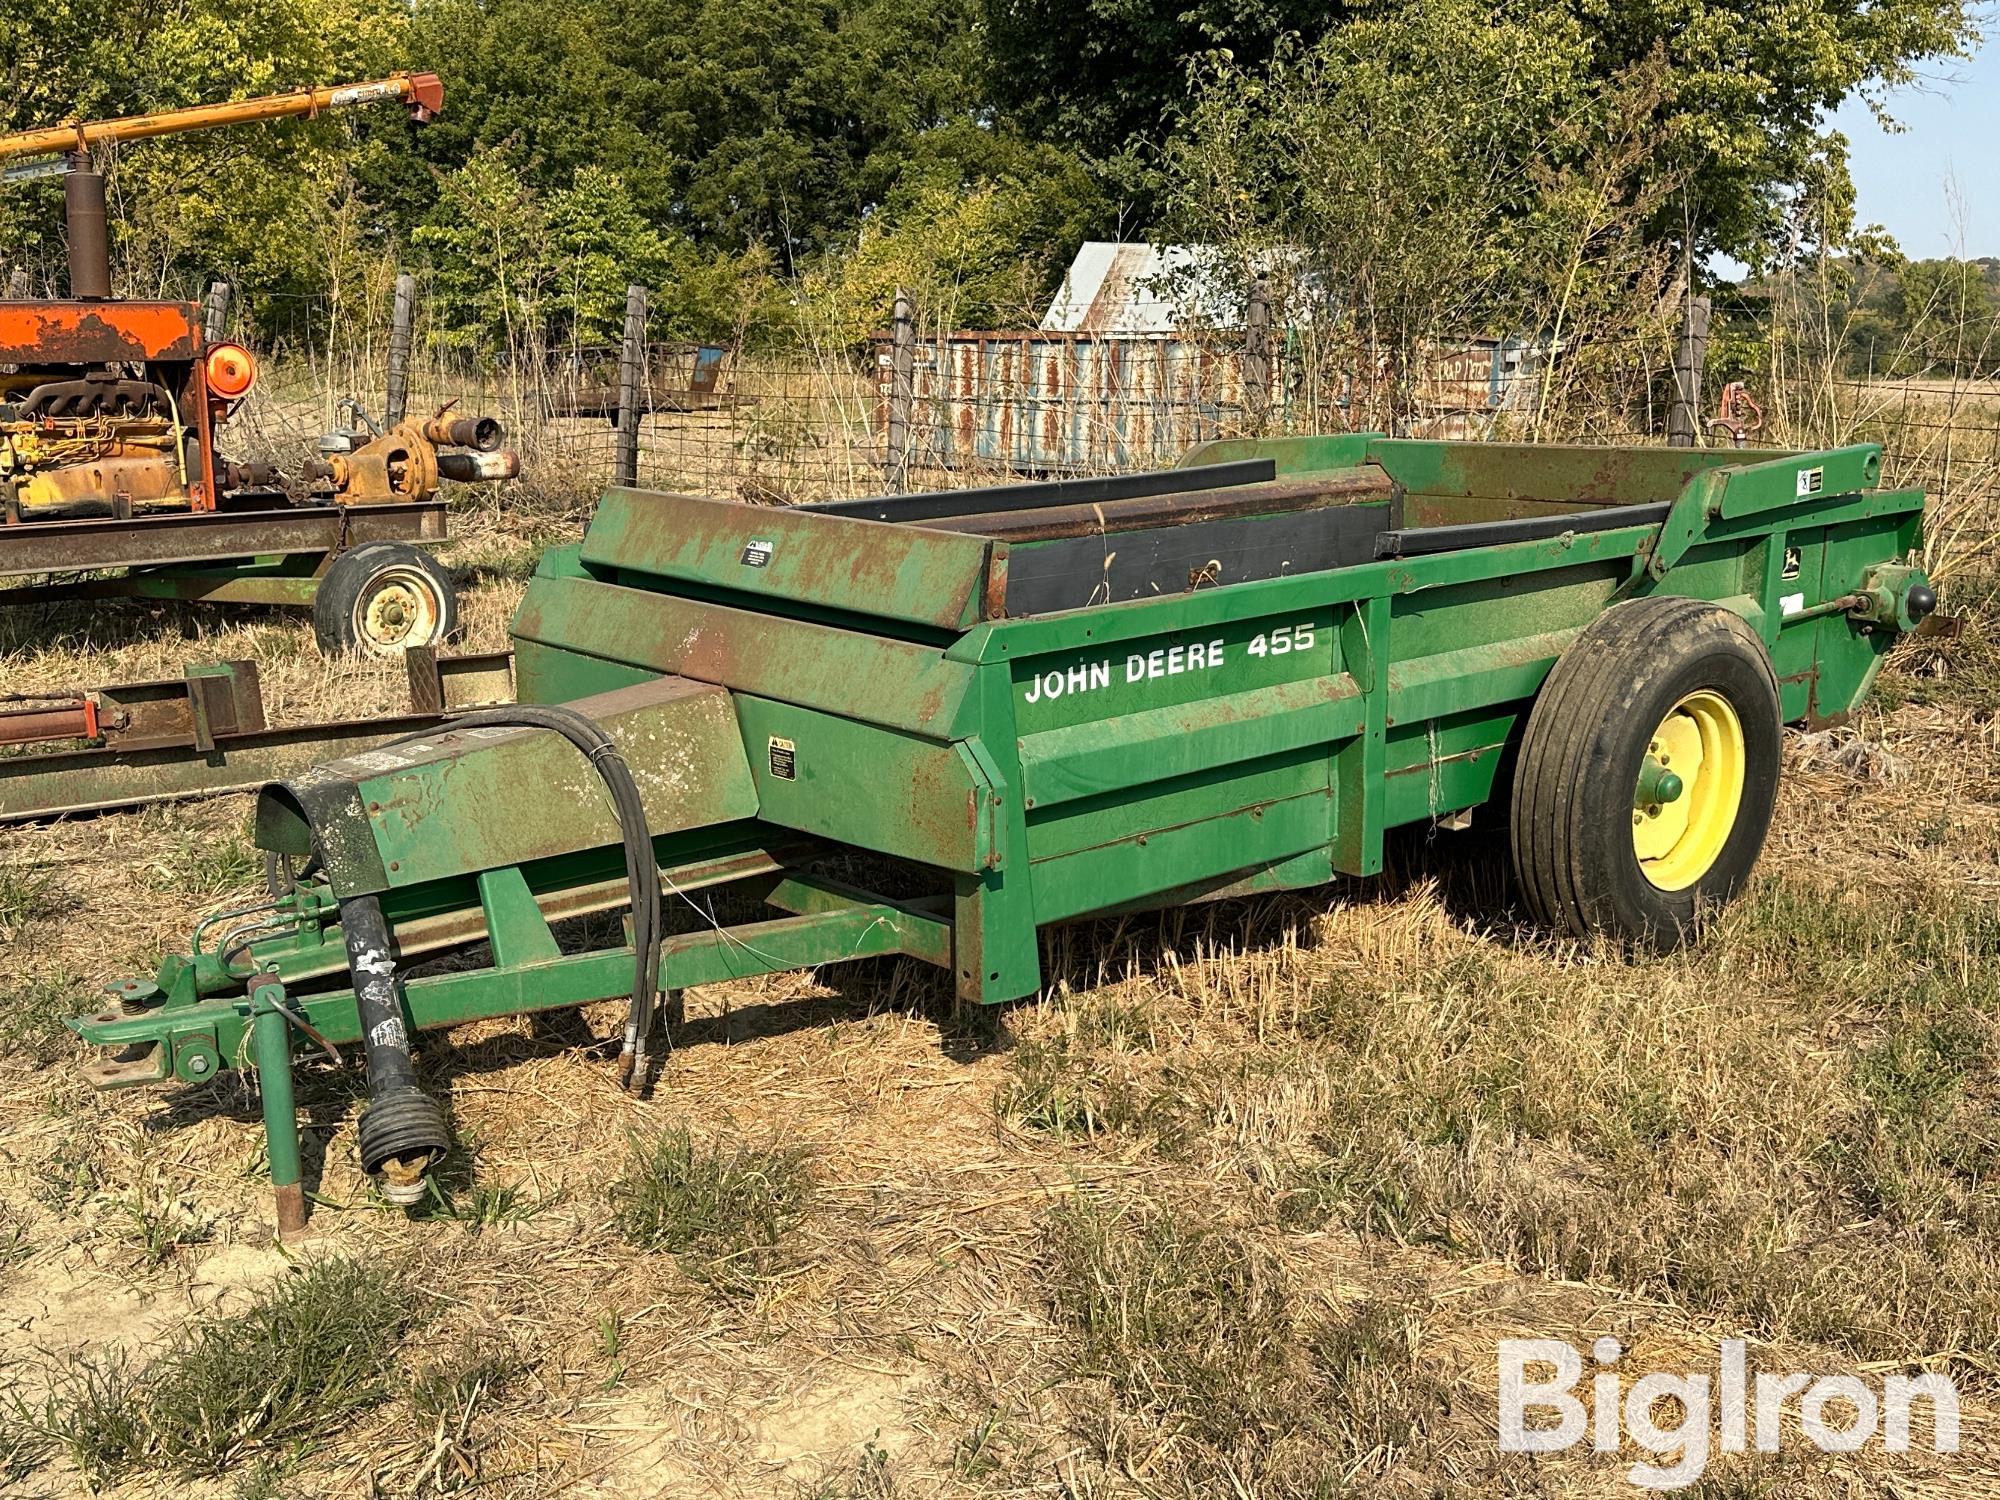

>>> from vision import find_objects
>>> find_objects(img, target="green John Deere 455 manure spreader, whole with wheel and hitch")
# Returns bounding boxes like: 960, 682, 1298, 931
76, 434, 1936, 1226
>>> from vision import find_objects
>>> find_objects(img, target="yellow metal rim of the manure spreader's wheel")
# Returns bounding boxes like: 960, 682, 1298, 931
1632, 690, 1744, 890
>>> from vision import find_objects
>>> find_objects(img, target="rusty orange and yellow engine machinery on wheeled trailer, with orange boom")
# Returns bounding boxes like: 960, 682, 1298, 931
0, 74, 518, 654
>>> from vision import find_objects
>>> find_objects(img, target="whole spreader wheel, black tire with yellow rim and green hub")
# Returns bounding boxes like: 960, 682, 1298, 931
1512, 598, 1782, 952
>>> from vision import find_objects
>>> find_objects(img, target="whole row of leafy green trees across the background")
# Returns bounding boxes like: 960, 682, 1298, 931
0, 0, 1972, 348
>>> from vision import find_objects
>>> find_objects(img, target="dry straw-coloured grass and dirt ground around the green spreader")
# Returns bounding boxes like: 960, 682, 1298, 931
0, 500, 2000, 1500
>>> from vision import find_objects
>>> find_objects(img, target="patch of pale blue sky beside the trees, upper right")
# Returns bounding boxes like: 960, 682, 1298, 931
1832, 27, 2000, 260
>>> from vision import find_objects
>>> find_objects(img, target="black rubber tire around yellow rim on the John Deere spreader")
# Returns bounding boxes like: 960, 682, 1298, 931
1510, 596, 1782, 952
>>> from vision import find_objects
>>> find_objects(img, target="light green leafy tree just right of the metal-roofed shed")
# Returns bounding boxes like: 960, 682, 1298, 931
1164, 0, 1674, 426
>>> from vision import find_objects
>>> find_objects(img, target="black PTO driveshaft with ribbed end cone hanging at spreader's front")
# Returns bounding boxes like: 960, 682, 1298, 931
340, 896, 450, 1208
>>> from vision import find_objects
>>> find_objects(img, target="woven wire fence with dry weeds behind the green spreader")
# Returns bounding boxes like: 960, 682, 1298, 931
207, 276, 2000, 560
